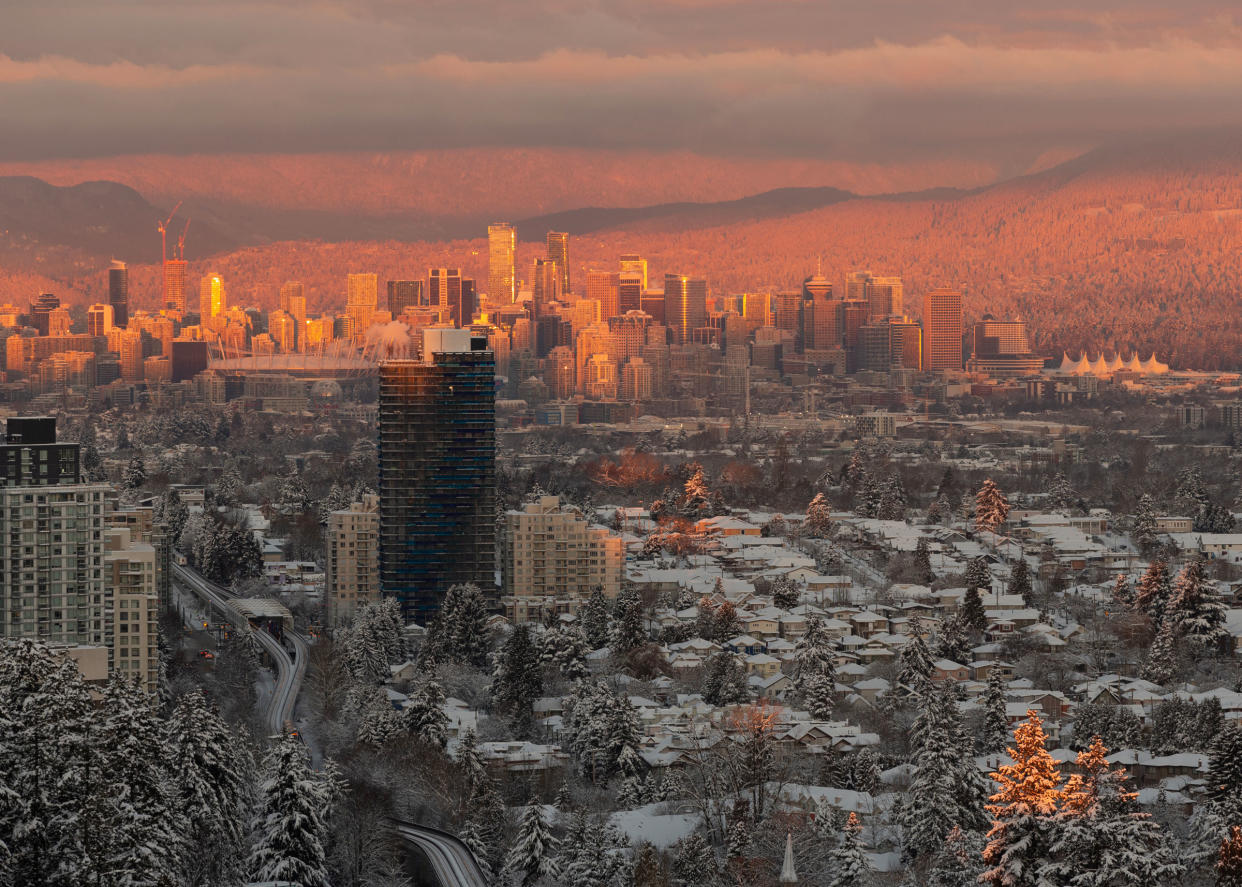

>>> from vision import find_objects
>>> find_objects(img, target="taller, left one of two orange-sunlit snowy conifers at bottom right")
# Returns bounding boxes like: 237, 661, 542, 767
980, 712, 1061, 887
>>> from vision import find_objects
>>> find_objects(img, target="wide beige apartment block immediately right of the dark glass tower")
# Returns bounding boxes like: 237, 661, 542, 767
502, 496, 625, 622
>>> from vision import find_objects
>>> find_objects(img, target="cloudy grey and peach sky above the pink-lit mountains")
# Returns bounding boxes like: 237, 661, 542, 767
0, 0, 1242, 163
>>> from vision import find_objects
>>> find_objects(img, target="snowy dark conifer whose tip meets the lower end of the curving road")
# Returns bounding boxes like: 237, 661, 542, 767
250, 735, 328, 887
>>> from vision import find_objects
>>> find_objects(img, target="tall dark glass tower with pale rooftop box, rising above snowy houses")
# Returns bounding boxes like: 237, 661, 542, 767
379, 328, 496, 624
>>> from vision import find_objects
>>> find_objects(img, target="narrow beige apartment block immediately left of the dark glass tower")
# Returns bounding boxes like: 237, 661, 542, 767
324, 496, 380, 625
